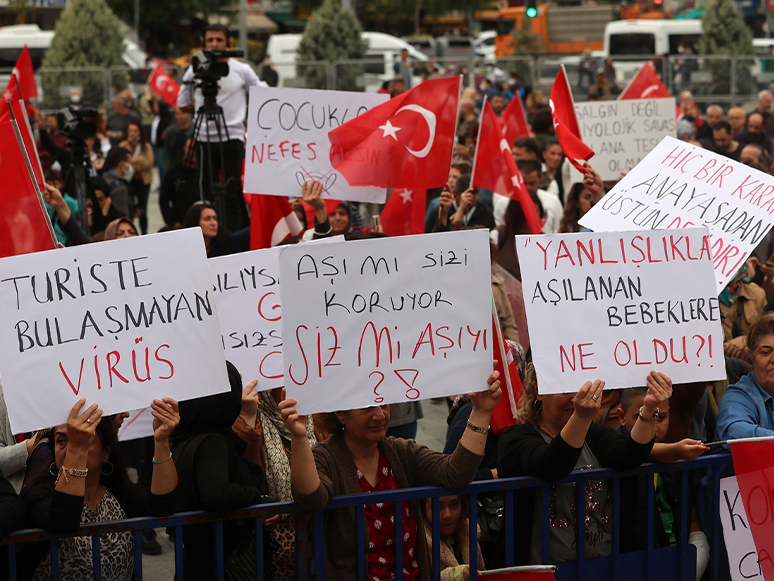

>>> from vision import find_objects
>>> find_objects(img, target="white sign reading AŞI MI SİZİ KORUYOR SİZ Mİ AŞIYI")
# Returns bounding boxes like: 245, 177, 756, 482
280, 230, 492, 414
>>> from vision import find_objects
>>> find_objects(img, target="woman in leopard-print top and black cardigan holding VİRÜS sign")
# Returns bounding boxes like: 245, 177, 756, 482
23, 397, 180, 580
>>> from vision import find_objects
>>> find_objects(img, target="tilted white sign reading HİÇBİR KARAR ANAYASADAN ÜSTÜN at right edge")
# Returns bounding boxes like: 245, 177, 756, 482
579, 137, 774, 294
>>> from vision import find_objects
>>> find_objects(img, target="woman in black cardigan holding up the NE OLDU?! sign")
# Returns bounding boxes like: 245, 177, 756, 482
497, 365, 672, 564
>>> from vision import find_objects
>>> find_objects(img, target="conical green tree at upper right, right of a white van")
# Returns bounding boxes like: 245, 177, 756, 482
700, 0, 755, 95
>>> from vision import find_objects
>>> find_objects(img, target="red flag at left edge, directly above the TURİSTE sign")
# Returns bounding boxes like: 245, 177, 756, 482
0, 121, 56, 257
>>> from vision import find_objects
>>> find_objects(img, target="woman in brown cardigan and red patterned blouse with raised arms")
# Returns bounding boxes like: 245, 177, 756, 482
279, 371, 501, 579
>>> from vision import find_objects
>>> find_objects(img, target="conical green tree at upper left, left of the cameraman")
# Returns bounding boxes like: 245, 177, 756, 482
41, 0, 124, 109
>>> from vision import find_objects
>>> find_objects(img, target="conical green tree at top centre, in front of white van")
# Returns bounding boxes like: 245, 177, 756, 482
296, 0, 368, 91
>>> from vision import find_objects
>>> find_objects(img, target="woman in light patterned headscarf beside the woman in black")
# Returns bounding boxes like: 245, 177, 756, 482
234, 387, 317, 580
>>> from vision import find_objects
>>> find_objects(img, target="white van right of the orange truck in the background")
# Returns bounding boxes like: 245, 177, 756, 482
604, 20, 702, 86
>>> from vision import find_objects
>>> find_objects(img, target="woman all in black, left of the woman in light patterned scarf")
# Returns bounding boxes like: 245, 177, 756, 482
172, 363, 263, 579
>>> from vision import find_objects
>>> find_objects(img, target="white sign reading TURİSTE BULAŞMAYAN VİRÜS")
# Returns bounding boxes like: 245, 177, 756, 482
0, 228, 229, 433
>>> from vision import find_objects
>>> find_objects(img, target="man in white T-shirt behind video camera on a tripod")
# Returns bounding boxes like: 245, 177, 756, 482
177, 24, 266, 232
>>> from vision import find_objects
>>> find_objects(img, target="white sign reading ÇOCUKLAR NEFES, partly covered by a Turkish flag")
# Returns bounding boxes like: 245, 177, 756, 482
244, 87, 389, 204
